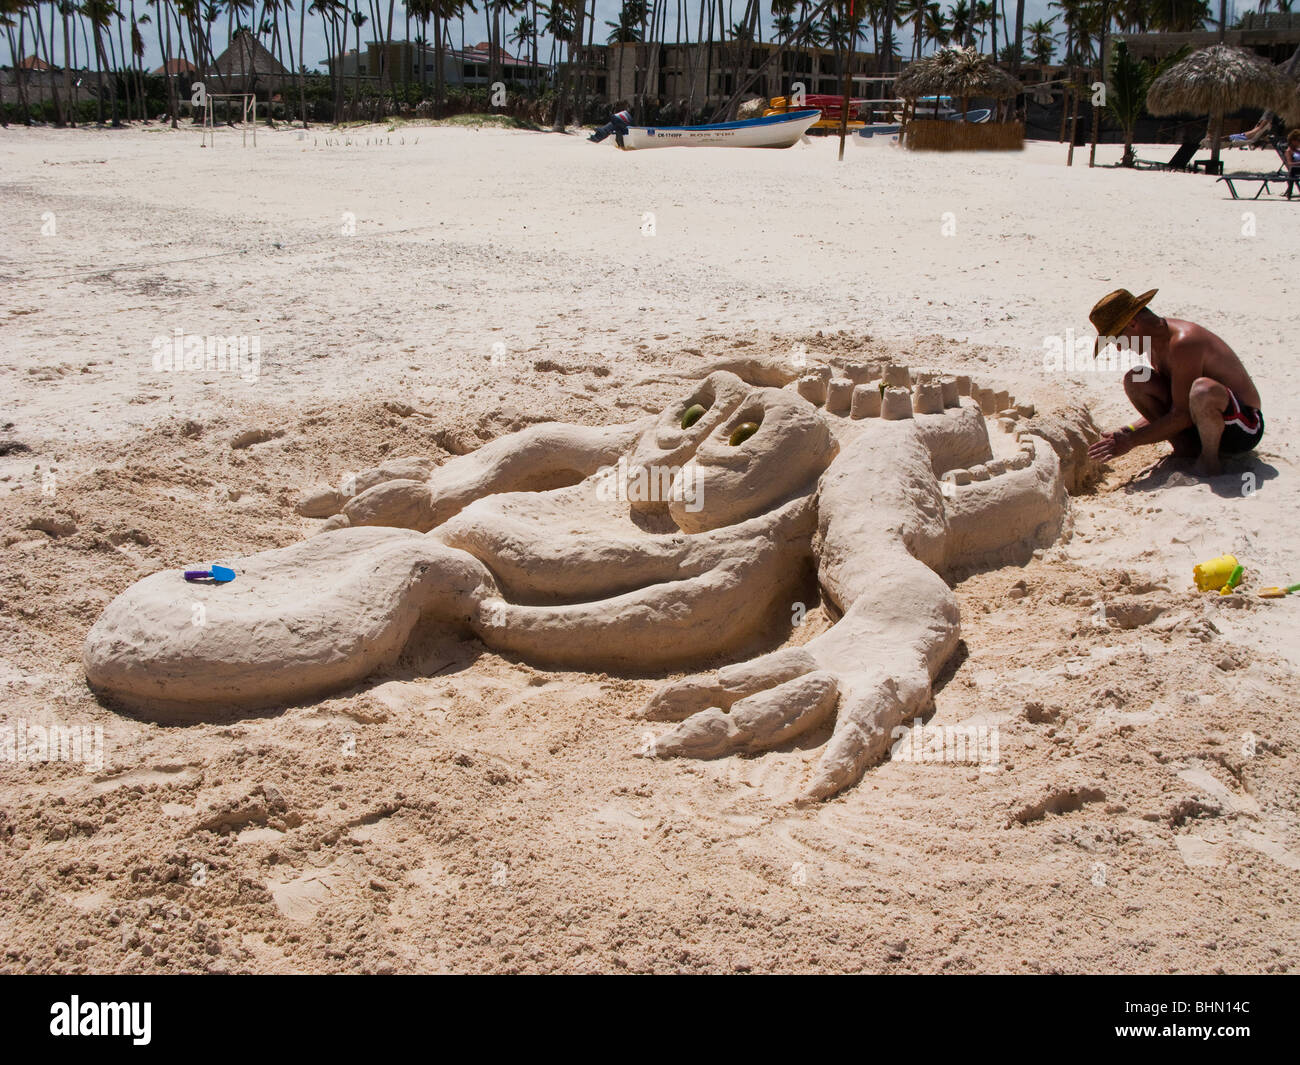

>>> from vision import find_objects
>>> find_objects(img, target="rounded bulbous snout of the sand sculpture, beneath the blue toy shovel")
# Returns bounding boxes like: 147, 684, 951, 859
83, 528, 497, 722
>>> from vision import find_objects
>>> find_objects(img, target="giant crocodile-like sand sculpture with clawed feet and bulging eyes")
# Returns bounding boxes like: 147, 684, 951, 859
85, 359, 1097, 797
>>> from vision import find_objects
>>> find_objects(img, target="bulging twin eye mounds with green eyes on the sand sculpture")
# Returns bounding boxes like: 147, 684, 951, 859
613, 372, 836, 532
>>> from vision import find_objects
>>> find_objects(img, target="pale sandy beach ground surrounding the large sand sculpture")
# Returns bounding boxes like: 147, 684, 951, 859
0, 125, 1300, 973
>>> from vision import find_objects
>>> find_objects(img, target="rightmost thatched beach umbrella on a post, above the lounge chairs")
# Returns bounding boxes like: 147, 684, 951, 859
1147, 44, 1295, 170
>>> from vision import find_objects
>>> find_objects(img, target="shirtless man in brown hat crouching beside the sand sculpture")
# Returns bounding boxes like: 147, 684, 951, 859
1088, 289, 1264, 477
